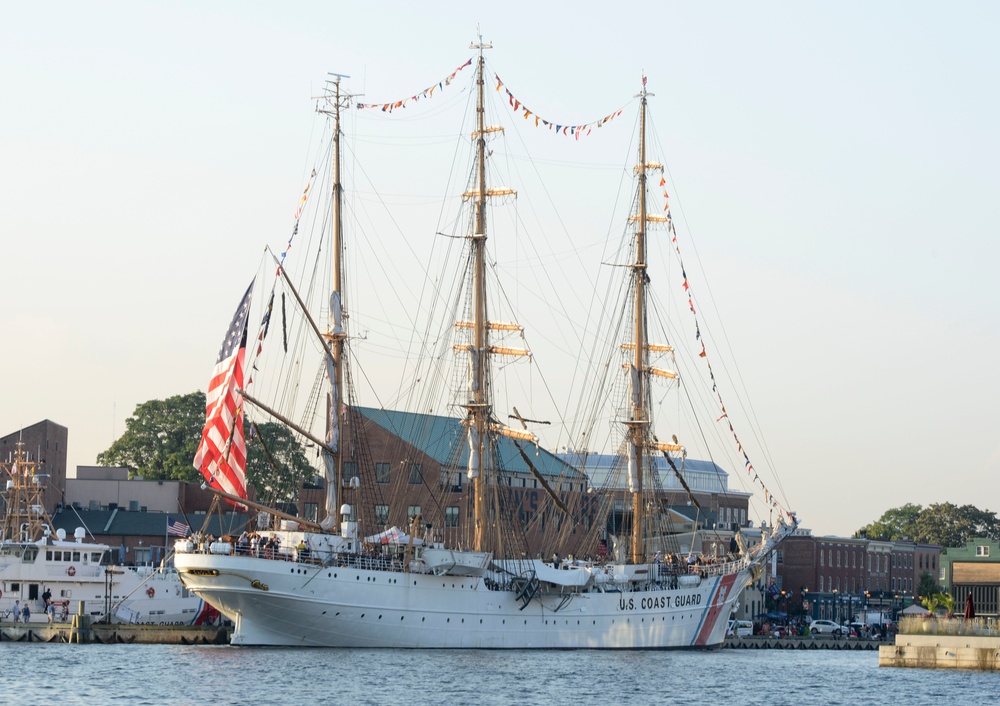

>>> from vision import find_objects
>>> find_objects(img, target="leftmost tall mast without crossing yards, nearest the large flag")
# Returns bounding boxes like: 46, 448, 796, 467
319, 74, 350, 526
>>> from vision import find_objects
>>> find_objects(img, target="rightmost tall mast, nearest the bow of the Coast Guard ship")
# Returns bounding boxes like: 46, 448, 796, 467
623, 77, 683, 564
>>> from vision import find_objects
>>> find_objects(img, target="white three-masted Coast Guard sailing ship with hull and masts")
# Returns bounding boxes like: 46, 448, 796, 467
176, 43, 794, 649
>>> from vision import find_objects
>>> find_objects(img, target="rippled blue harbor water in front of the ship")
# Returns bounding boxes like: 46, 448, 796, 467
0, 642, 1000, 706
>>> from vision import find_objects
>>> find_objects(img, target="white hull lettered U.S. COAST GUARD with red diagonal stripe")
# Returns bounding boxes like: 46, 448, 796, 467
175, 554, 751, 649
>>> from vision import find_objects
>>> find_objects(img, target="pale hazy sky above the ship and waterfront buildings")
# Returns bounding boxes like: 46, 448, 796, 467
0, 1, 1000, 535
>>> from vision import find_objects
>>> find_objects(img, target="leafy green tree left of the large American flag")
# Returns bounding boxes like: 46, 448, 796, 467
97, 392, 205, 483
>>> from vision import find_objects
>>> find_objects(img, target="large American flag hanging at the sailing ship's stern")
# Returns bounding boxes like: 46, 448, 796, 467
194, 282, 253, 498
